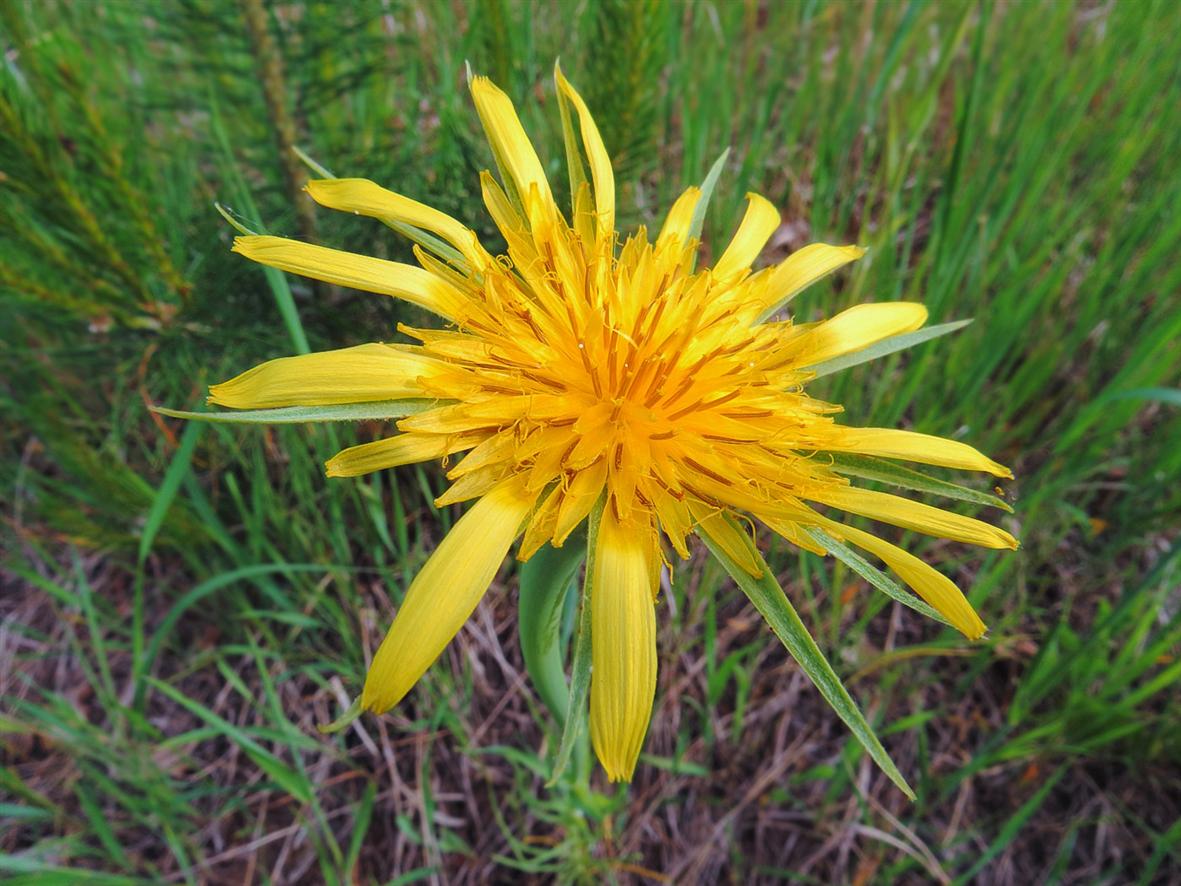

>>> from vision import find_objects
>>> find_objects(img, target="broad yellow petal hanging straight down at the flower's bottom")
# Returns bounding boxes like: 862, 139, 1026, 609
591, 508, 657, 781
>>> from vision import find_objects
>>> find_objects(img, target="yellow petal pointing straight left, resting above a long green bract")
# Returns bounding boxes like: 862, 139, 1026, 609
209, 344, 443, 409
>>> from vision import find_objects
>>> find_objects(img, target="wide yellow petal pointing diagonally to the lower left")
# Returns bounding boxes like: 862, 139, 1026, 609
361, 478, 536, 714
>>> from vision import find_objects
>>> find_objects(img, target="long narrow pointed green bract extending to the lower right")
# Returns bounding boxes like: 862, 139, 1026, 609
697, 515, 914, 800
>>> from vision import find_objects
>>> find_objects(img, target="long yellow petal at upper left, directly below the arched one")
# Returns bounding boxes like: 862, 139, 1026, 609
234, 236, 466, 320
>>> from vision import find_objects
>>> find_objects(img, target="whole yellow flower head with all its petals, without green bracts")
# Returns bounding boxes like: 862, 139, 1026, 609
209, 64, 1017, 781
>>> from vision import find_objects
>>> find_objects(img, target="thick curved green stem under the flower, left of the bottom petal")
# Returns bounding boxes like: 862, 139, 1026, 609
517, 541, 586, 724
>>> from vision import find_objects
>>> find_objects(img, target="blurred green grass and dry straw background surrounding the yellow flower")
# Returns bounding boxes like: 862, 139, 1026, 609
0, 0, 1181, 884
